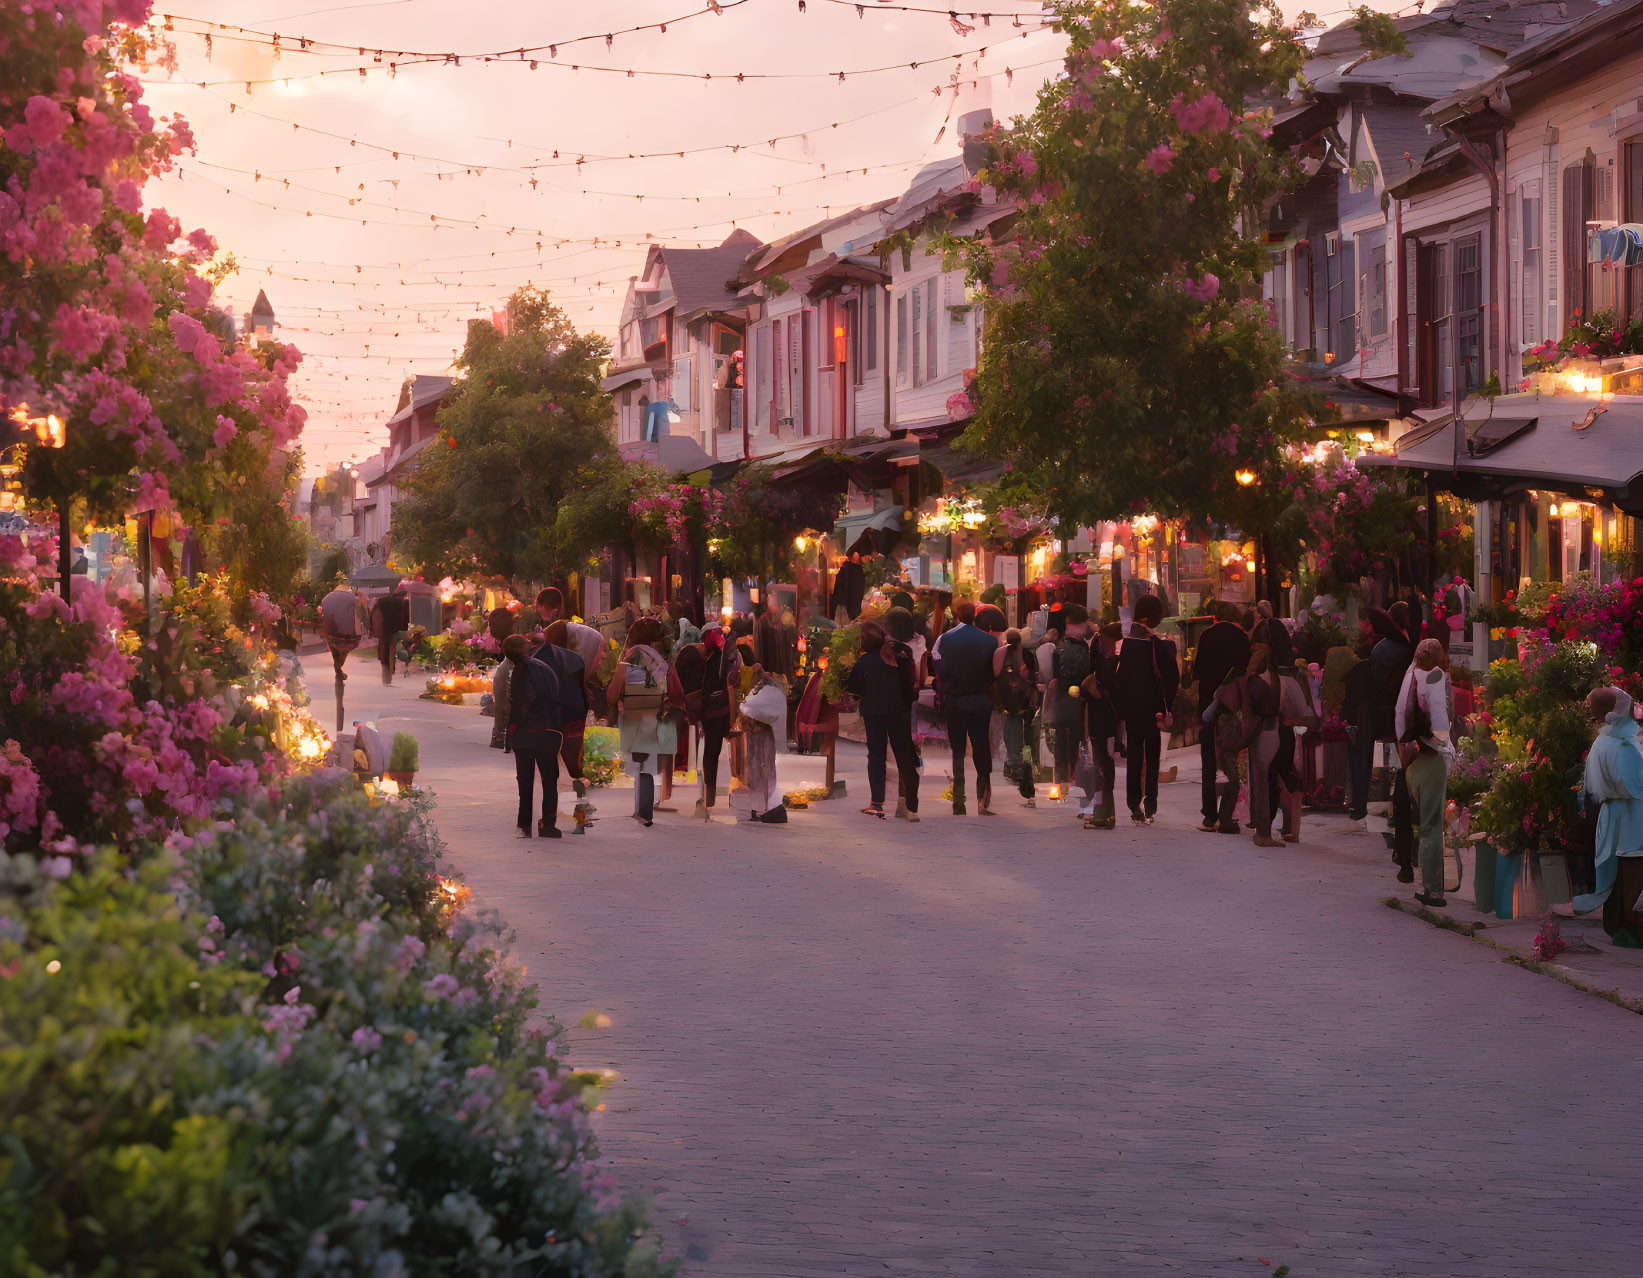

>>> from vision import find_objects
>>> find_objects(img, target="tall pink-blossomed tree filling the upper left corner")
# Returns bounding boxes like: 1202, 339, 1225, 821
0, 0, 306, 537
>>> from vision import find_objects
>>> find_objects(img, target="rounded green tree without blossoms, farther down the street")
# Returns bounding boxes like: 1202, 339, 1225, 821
394, 287, 616, 585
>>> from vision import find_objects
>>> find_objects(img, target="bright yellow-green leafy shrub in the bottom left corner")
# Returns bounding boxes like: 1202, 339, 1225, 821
0, 853, 265, 1278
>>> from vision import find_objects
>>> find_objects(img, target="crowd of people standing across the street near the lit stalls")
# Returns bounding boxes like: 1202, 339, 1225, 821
479, 588, 1456, 903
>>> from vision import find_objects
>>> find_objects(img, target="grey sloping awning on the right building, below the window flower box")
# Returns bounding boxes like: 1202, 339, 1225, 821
1357, 394, 1643, 513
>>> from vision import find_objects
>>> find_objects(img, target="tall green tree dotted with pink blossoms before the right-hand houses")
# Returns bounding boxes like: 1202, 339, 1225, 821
938, 0, 1309, 542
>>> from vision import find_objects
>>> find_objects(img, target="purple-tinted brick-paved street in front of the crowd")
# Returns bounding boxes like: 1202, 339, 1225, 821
309, 660, 1643, 1278
